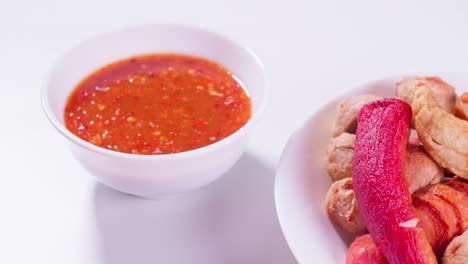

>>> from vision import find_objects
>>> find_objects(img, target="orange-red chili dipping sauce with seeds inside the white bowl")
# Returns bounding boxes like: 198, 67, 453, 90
64, 54, 252, 154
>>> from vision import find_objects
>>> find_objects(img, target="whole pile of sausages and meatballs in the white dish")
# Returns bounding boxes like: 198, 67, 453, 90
325, 77, 468, 264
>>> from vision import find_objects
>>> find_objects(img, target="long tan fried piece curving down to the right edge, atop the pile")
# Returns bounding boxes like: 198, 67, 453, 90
412, 82, 468, 178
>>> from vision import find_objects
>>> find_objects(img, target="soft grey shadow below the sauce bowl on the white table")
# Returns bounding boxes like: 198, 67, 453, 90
94, 153, 296, 264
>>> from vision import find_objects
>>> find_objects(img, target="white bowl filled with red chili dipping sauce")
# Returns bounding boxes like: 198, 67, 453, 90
41, 24, 267, 198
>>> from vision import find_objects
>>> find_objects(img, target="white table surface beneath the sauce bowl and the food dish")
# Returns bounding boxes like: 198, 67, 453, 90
0, 0, 468, 264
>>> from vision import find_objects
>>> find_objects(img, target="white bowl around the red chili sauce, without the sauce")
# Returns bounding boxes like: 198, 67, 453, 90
41, 25, 267, 198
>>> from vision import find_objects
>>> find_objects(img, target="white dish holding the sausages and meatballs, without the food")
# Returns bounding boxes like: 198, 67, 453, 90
275, 71, 468, 264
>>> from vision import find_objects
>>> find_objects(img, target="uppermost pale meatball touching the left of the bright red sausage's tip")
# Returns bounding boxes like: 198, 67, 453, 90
332, 94, 381, 137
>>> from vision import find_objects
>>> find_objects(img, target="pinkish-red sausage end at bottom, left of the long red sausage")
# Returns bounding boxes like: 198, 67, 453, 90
346, 234, 387, 264
